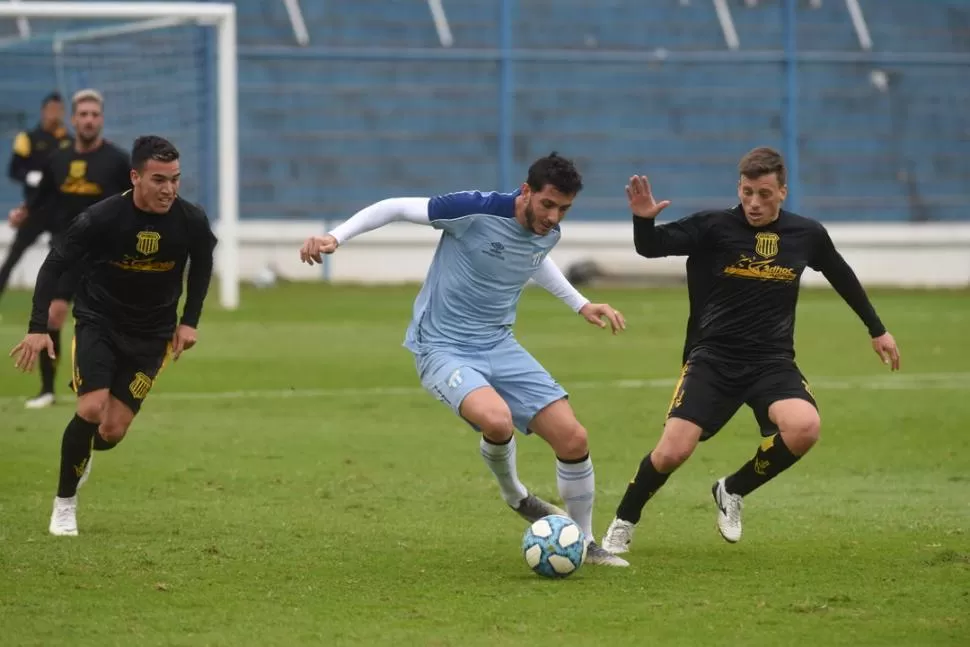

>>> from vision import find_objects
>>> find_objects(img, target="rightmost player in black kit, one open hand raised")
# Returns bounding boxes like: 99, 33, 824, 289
602, 148, 899, 553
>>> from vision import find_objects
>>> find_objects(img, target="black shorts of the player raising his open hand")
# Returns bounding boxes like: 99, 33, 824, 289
667, 353, 818, 440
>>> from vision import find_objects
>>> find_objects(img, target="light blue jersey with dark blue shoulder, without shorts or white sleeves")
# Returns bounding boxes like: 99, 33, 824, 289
404, 191, 560, 353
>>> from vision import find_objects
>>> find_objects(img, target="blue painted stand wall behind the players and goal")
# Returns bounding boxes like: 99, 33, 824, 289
0, 0, 970, 221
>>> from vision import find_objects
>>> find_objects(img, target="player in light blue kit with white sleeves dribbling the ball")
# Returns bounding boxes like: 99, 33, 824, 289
300, 153, 628, 566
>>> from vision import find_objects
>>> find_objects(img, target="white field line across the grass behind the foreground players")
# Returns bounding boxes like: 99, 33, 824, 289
0, 373, 970, 404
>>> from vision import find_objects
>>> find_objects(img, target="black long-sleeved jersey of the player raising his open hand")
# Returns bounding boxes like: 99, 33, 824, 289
633, 205, 886, 362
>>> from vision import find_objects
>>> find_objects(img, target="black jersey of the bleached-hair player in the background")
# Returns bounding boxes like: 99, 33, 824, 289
27, 141, 131, 233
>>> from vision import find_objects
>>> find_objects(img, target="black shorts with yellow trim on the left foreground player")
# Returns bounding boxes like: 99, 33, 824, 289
71, 323, 171, 413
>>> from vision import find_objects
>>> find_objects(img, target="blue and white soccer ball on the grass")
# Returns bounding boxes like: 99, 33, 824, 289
522, 514, 586, 578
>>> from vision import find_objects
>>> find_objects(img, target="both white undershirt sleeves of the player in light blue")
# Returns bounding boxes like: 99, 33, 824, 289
330, 198, 589, 312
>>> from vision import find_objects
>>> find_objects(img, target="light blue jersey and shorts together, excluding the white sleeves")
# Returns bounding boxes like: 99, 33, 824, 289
404, 191, 566, 433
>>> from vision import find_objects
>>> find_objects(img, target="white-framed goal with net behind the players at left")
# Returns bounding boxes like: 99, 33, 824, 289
0, 0, 239, 308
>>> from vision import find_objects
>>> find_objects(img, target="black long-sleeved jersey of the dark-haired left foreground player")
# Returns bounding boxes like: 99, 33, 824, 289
30, 191, 216, 337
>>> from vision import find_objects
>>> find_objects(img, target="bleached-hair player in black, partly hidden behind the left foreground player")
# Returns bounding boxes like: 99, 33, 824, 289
12, 89, 131, 409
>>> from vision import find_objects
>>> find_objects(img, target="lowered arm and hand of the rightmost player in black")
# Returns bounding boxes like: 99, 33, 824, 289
809, 225, 899, 371
